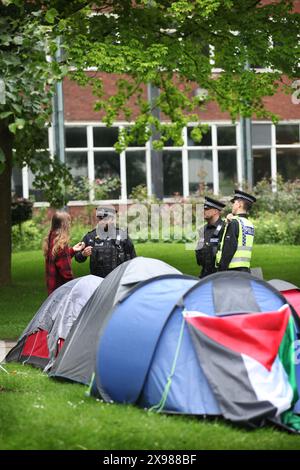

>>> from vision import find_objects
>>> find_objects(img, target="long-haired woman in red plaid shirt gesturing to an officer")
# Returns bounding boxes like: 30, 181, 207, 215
43, 211, 85, 295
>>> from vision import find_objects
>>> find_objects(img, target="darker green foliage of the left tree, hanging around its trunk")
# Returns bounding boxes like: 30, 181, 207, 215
0, 0, 88, 205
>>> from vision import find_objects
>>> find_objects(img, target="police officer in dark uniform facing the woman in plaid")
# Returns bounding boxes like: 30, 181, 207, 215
75, 206, 136, 277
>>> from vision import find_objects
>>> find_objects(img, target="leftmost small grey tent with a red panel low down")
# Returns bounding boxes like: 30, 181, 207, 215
5, 275, 103, 369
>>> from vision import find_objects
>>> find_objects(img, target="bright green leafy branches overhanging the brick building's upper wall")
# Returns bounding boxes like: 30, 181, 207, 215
63, 0, 300, 149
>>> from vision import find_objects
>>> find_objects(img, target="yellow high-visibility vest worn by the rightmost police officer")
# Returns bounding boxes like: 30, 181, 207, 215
216, 215, 254, 269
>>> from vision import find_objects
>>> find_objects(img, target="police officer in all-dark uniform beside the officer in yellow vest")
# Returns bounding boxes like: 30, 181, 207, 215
196, 197, 225, 278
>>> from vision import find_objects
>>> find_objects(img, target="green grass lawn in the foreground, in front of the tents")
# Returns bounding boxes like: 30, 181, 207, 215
0, 364, 300, 450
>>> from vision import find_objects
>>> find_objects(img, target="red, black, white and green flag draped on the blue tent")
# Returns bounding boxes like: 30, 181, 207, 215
183, 305, 298, 425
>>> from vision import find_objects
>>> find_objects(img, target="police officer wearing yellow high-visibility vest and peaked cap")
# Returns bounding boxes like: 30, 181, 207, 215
216, 190, 256, 272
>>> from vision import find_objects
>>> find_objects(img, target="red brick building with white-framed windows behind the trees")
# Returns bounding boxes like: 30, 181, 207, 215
13, 2, 300, 207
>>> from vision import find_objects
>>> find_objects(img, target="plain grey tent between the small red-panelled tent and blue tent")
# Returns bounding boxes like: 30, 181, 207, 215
49, 257, 181, 384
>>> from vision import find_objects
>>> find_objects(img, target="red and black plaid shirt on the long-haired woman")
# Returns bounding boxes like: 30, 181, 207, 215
46, 232, 75, 295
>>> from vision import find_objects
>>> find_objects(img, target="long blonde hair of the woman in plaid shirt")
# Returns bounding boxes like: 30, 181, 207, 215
43, 211, 71, 258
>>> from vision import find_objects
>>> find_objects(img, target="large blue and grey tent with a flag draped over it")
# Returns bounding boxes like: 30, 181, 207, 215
91, 272, 300, 432
